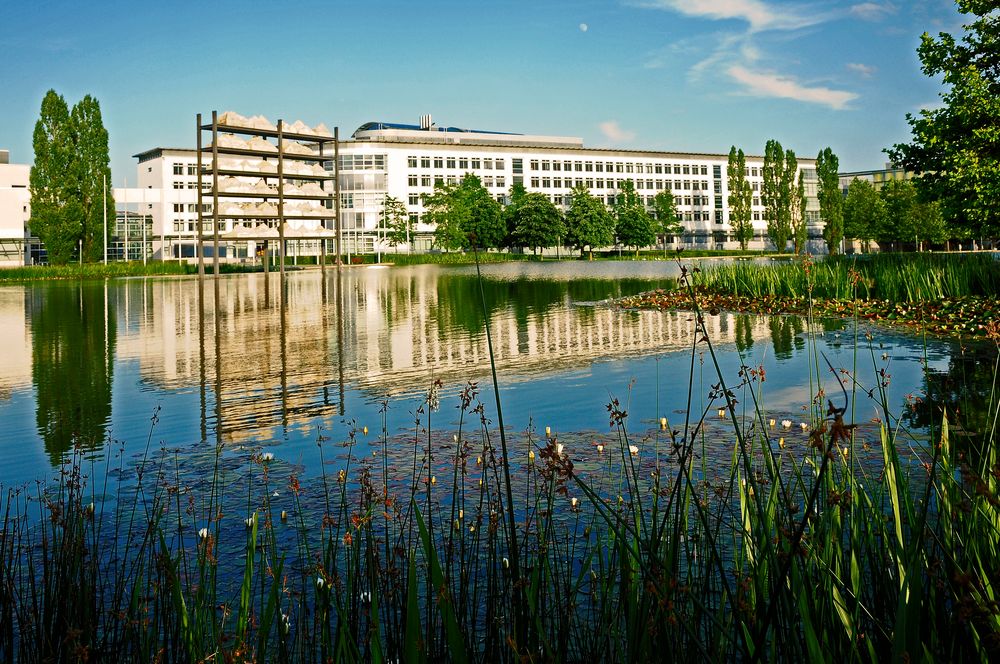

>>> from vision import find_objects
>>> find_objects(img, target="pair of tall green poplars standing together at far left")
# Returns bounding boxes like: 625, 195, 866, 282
29, 90, 115, 265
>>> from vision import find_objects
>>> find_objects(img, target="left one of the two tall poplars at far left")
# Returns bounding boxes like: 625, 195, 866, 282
28, 90, 83, 265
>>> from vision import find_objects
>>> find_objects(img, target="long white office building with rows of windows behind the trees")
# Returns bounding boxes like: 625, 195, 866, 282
131, 116, 822, 259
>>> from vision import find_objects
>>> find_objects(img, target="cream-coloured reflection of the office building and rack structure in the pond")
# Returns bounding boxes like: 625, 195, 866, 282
111, 268, 768, 443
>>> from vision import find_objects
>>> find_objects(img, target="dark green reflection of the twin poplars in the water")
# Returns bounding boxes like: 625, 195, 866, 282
25, 284, 117, 464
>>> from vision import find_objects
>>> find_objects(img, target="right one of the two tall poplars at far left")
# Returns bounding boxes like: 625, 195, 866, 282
70, 95, 115, 261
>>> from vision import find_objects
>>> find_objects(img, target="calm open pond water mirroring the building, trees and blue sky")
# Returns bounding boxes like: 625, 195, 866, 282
0, 262, 979, 486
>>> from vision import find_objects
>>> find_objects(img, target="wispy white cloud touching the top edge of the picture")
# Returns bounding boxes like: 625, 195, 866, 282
638, 0, 831, 32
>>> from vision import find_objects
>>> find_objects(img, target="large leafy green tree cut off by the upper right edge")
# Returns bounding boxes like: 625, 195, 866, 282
887, 0, 1000, 238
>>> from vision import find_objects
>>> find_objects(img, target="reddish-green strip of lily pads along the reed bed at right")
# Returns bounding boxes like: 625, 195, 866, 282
617, 287, 1000, 338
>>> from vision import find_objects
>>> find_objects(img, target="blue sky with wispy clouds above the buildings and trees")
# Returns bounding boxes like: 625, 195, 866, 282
0, 0, 963, 179
